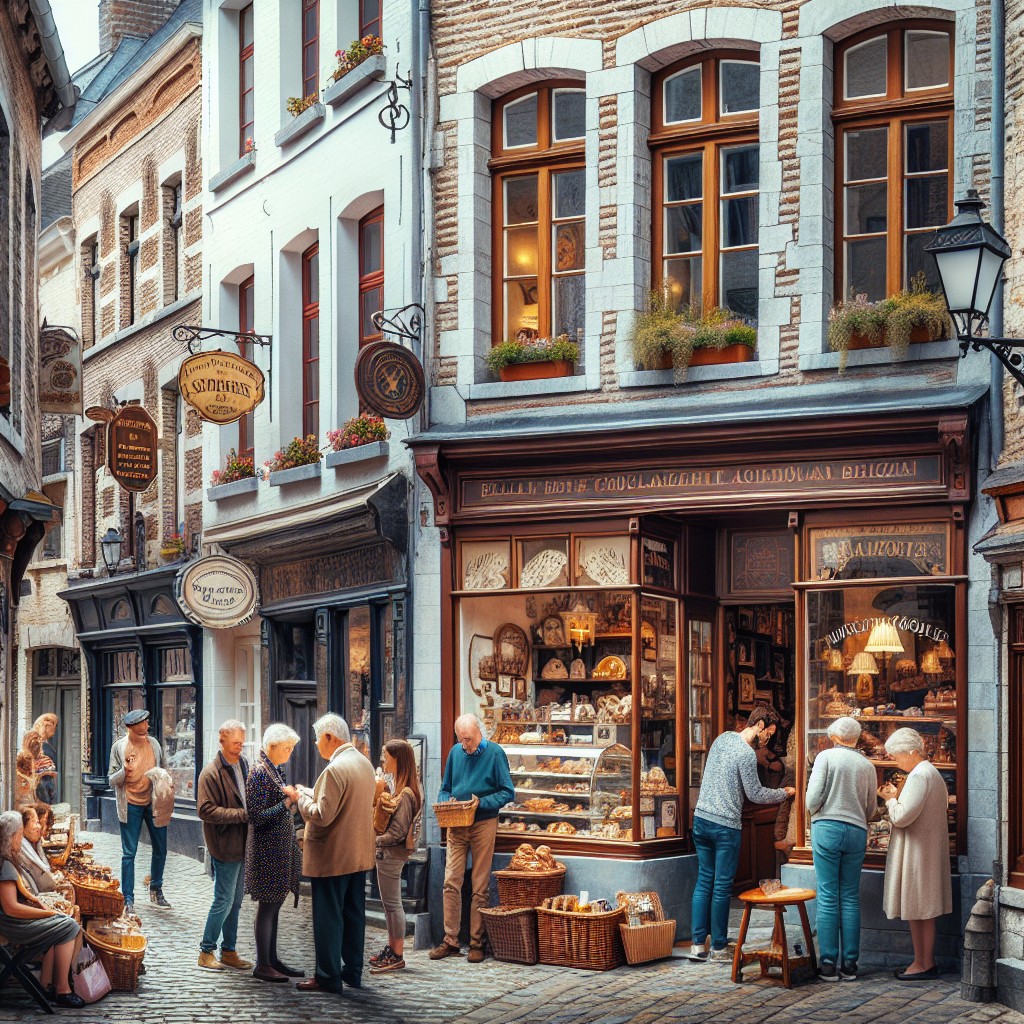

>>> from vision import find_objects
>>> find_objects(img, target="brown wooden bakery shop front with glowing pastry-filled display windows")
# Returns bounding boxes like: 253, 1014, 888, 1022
412, 394, 972, 936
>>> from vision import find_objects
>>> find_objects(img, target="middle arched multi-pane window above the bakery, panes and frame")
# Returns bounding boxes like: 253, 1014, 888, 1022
650, 52, 760, 324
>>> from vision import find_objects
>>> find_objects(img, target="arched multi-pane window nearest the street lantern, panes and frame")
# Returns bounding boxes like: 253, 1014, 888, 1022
833, 23, 953, 300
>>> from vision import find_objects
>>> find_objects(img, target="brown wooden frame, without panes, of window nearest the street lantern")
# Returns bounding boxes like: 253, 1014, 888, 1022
833, 20, 955, 301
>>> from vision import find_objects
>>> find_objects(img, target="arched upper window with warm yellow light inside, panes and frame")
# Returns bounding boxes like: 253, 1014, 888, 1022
490, 82, 587, 344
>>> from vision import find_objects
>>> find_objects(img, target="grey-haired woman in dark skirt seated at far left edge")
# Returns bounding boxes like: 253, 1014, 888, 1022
0, 811, 85, 1010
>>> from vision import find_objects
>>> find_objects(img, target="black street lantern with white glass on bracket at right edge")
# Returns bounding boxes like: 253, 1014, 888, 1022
925, 188, 1024, 386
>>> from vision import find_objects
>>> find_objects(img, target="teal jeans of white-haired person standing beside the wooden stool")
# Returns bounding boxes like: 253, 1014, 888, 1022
811, 821, 867, 964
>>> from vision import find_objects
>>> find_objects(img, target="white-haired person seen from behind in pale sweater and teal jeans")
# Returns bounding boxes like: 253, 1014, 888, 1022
807, 717, 878, 981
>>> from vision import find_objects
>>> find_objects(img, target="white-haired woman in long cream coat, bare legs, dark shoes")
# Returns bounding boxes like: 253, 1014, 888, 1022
879, 729, 953, 981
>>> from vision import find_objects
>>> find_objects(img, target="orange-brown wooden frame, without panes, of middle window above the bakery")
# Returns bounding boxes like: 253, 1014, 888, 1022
648, 50, 761, 317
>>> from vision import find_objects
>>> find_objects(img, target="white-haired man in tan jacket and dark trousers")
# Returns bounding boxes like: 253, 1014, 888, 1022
284, 715, 376, 993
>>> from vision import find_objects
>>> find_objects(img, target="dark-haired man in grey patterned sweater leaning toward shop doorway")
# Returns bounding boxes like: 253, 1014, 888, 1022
689, 705, 797, 964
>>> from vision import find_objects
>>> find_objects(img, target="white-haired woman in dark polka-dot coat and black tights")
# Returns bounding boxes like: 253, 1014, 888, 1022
246, 722, 303, 982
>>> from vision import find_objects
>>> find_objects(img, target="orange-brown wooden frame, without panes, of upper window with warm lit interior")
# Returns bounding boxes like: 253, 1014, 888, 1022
487, 79, 587, 345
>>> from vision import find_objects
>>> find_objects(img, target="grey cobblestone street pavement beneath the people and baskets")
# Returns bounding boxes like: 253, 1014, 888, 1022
0, 835, 1024, 1024
